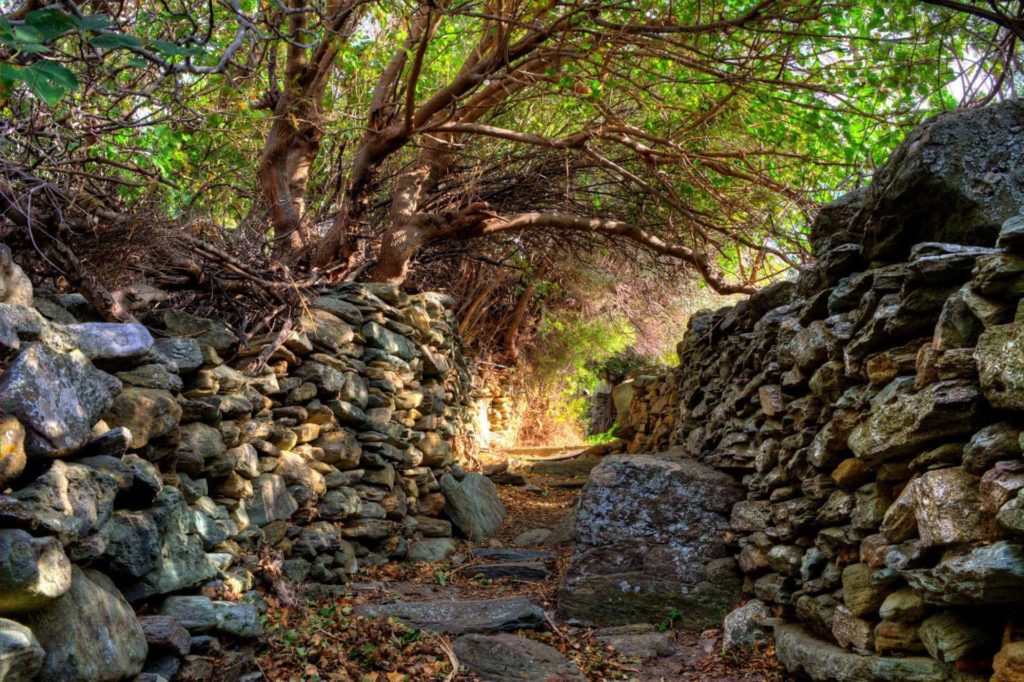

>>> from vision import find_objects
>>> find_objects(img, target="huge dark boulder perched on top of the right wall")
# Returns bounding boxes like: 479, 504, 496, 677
861, 101, 1024, 261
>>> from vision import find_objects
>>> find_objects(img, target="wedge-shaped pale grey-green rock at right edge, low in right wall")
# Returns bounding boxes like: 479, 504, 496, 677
901, 541, 1024, 605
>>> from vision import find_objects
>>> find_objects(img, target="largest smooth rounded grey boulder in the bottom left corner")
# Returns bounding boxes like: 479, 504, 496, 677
26, 566, 148, 682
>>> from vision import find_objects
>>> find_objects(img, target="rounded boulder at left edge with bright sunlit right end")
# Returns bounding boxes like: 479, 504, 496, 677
0, 528, 71, 614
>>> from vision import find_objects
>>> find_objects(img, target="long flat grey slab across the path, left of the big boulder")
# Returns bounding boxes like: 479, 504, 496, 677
355, 597, 544, 635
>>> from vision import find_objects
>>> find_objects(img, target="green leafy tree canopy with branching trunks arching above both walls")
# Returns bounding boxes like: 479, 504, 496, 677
0, 0, 1021, 316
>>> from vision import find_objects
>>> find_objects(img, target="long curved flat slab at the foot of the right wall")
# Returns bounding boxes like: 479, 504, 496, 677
775, 624, 953, 682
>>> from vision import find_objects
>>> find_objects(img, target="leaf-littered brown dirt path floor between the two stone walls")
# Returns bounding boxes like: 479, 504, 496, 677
259, 458, 787, 682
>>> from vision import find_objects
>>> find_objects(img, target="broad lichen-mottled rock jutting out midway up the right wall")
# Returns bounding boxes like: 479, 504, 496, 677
849, 377, 981, 462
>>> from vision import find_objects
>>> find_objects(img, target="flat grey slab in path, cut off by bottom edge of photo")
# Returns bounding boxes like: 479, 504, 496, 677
454, 634, 587, 682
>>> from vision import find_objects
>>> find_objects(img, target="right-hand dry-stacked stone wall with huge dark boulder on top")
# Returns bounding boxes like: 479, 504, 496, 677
624, 102, 1024, 682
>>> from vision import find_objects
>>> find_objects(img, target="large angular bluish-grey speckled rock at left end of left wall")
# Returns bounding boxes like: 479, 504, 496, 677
0, 343, 121, 457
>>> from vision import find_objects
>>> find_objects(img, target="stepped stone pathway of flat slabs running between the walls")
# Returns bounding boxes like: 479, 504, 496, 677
339, 452, 788, 682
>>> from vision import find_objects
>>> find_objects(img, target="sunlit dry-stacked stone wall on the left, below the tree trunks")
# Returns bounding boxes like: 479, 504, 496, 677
0, 274, 485, 681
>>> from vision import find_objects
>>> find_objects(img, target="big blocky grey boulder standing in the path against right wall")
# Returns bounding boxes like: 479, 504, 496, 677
558, 455, 741, 629
